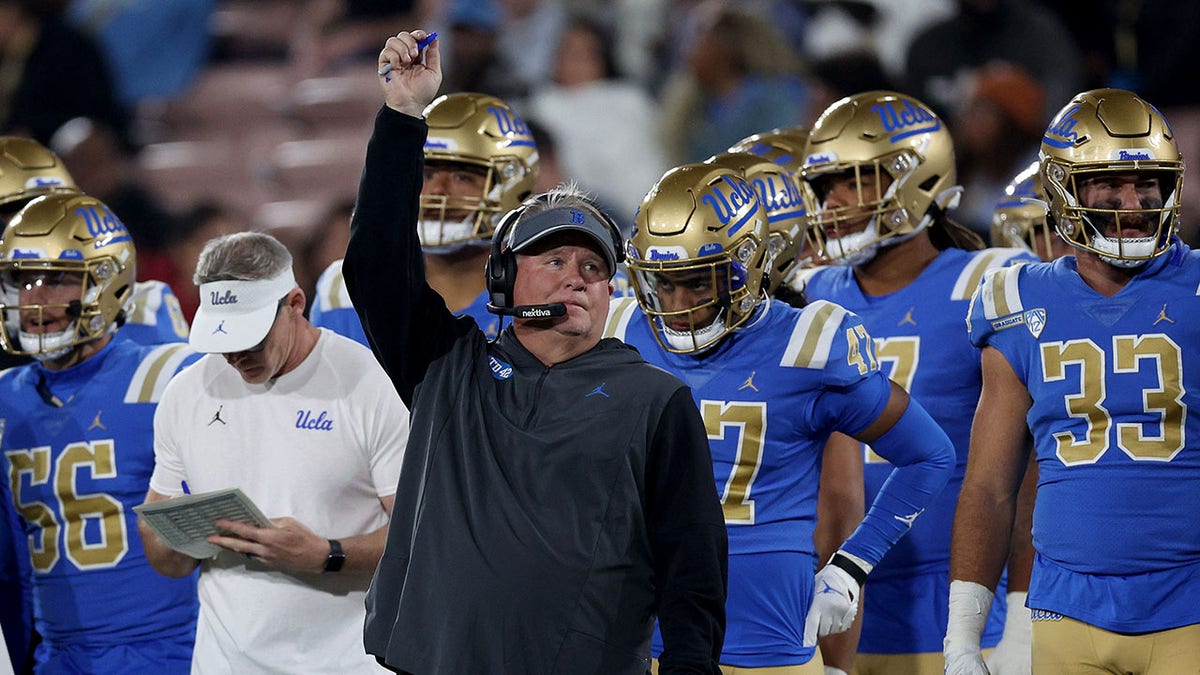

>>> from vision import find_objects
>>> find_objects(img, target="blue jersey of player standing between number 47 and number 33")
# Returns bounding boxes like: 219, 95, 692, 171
804, 249, 1037, 653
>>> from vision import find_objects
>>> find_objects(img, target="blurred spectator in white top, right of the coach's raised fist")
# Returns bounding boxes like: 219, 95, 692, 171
529, 17, 668, 222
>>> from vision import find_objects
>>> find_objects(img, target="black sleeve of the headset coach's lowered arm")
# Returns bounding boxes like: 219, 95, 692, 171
647, 388, 728, 675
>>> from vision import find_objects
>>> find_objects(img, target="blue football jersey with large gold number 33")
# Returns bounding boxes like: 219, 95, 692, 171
968, 241, 1200, 632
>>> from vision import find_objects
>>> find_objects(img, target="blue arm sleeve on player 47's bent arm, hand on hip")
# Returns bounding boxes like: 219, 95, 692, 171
841, 399, 954, 567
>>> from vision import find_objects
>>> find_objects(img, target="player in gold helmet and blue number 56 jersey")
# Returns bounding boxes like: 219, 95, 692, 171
0, 193, 197, 673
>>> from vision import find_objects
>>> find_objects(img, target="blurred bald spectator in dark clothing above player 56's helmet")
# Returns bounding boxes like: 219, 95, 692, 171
50, 118, 181, 278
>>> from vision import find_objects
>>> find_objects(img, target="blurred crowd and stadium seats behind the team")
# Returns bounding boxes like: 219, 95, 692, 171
0, 0, 1200, 319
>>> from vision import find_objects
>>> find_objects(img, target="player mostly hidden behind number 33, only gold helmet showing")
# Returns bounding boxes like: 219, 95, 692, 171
991, 161, 1074, 262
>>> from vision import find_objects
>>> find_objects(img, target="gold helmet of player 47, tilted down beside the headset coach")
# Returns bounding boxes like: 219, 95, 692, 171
626, 163, 768, 353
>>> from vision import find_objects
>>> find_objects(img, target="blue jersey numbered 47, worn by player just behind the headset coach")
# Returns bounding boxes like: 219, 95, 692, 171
606, 298, 890, 668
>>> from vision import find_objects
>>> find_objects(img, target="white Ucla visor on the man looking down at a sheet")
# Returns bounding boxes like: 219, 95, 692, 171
187, 268, 296, 354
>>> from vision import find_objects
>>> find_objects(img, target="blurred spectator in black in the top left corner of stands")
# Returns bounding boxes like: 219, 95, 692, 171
0, 0, 133, 148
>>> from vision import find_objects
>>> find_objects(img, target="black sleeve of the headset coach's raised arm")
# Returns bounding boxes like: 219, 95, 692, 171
342, 106, 465, 398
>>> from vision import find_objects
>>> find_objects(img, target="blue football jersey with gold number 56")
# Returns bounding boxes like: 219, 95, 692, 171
0, 336, 198, 663
